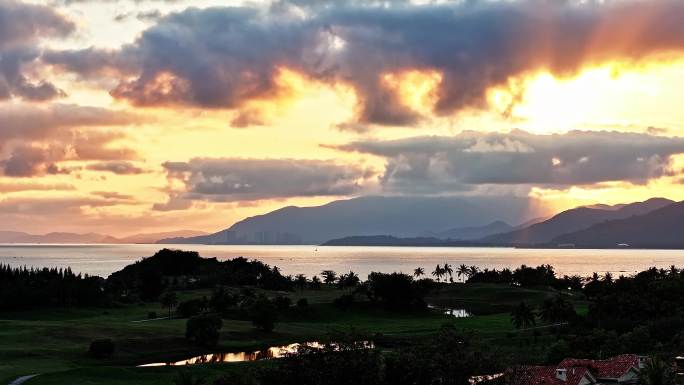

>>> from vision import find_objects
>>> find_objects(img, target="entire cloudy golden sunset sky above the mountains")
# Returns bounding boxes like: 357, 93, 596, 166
0, 0, 684, 236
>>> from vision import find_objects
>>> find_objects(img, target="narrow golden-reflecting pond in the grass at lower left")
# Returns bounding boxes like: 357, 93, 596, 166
138, 341, 374, 367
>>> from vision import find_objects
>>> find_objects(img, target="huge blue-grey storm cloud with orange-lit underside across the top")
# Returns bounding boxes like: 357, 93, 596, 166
45, 0, 684, 124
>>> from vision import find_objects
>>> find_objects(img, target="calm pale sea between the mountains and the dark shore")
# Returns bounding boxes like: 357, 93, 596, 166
0, 244, 684, 278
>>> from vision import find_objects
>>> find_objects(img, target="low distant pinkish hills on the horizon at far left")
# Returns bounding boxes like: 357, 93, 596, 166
0, 230, 206, 243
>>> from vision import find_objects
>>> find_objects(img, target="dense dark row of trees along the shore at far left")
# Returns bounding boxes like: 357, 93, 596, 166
0, 265, 108, 310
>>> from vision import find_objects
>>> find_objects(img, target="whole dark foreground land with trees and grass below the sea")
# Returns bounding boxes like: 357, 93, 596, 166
0, 249, 684, 385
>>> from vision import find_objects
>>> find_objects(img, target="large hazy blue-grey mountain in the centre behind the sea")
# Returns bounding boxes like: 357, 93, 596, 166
160, 196, 546, 244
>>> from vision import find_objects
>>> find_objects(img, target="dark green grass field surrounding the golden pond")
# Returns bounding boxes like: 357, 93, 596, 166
0, 284, 586, 385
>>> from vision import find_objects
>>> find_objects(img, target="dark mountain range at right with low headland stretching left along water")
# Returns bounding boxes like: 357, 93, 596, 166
323, 198, 684, 248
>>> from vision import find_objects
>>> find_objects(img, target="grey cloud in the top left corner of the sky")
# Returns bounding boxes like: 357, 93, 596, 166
0, 0, 74, 101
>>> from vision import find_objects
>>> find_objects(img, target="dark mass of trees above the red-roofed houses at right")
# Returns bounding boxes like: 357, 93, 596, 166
502, 266, 684, 363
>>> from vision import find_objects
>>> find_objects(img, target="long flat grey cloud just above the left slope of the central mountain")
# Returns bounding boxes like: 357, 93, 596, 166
164, 158, 370, 201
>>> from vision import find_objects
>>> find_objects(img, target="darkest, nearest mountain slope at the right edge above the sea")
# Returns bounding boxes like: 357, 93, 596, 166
553, 202, 684, 248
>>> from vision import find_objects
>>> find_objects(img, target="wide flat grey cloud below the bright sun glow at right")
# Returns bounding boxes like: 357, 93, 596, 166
334, 130, 684, 193
